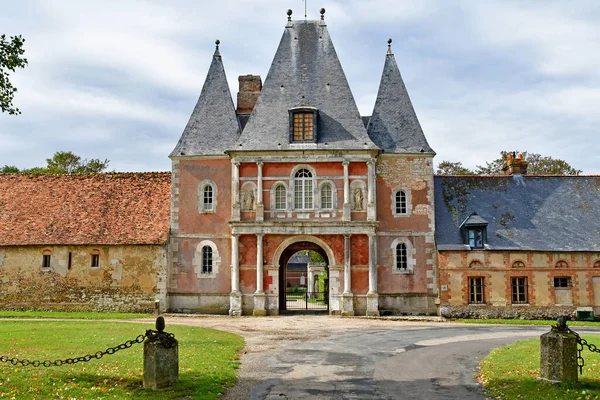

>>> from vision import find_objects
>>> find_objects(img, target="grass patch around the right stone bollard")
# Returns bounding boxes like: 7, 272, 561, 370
477, 335, 600, 400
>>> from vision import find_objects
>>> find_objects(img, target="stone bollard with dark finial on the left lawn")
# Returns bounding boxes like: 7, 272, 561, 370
144, 316, 179, 390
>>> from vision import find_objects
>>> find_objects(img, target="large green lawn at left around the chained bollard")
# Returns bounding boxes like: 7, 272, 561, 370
0, 320, 244, 399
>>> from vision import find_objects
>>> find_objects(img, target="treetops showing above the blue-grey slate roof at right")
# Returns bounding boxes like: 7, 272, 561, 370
437, 151, 581, 175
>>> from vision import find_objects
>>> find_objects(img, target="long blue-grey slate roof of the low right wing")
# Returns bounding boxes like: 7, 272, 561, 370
434, 175, 600, 251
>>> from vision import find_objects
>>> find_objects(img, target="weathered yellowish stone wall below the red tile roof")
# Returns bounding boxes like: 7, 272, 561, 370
0, 245, 166, 312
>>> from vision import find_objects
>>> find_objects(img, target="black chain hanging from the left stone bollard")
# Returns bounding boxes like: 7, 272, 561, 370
0, 329, 177, 367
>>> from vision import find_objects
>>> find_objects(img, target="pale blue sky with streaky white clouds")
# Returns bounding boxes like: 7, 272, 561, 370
0, 0, 600, 174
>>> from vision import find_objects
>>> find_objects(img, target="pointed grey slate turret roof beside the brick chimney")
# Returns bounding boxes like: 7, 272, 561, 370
170, 49, 240, 157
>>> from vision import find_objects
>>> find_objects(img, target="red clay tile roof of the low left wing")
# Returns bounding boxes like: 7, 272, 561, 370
0, 172, 171, 246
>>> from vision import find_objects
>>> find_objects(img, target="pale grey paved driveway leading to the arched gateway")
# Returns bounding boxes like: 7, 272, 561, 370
162, 317, 600, 400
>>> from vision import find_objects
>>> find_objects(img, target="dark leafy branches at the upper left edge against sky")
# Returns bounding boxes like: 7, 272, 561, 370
0, 35, 27, 115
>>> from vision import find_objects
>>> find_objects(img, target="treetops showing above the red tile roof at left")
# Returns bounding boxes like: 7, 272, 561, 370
0, 151, 110, 175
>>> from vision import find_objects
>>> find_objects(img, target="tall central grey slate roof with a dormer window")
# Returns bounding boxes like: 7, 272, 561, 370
230, 21, 378, 150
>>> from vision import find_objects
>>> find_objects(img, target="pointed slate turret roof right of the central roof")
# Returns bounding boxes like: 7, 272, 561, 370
367, 46, 435, 154
